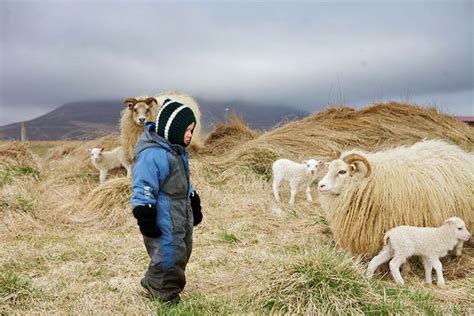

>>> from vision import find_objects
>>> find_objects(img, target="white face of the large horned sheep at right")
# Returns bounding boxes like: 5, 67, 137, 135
318, 159, 351, 195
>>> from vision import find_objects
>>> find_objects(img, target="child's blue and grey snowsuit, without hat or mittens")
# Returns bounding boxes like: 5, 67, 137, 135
131, 122, 193, 301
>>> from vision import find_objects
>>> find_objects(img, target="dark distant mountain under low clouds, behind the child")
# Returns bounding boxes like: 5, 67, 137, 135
0, 99, 309, 140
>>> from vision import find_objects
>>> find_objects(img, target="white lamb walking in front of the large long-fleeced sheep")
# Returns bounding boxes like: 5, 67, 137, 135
367, 217, 471, 287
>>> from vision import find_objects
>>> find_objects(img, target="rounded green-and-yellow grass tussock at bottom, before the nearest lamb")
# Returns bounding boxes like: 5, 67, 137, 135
252, 247, 370, 314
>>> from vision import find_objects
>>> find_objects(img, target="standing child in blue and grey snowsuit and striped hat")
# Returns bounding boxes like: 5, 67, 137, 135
131, 99, 202, 303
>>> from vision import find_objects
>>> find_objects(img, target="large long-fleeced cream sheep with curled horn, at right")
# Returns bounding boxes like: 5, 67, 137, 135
318, 140, 474, 255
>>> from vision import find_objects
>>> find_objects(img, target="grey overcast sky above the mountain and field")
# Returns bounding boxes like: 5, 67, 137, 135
0, 0, 474, 125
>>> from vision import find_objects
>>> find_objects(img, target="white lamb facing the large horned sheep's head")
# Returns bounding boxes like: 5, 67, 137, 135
272, 159, 324, 205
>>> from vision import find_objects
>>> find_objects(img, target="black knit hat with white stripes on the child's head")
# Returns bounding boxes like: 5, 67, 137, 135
156, 99, 196, 147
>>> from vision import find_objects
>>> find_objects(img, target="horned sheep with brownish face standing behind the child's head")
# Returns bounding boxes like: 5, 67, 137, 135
120, 91, 202, 162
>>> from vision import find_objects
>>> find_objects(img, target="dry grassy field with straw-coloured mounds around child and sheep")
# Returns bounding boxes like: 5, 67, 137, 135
0, 103, 474, 315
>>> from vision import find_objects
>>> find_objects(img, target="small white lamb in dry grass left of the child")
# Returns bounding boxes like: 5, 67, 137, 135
89, 146, 132, 184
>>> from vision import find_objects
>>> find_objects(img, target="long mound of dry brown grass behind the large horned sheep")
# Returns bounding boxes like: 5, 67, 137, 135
214, 102, 474, 179
